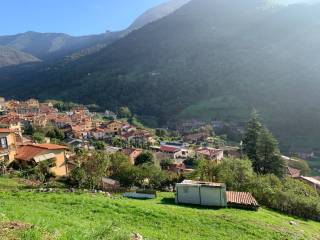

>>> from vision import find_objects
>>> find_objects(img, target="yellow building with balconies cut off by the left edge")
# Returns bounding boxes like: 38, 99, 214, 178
0, 128, 17, 163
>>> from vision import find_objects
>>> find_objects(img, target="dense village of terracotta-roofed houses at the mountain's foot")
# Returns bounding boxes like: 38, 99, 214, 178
0, 98, 230, 176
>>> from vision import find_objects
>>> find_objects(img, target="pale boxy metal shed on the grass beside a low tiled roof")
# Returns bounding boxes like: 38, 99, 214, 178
176, 180, 227, 207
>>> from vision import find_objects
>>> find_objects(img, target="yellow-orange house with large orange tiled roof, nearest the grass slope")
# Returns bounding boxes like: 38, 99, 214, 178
15, 144, 68, 177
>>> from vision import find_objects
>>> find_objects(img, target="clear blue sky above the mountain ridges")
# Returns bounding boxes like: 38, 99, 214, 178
0, 0, 166, 35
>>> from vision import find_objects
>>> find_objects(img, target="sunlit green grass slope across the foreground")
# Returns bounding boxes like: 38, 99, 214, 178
0, 178, 320, 240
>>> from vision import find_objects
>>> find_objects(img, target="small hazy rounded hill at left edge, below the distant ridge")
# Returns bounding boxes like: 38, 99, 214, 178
0, 46, 40, 68
